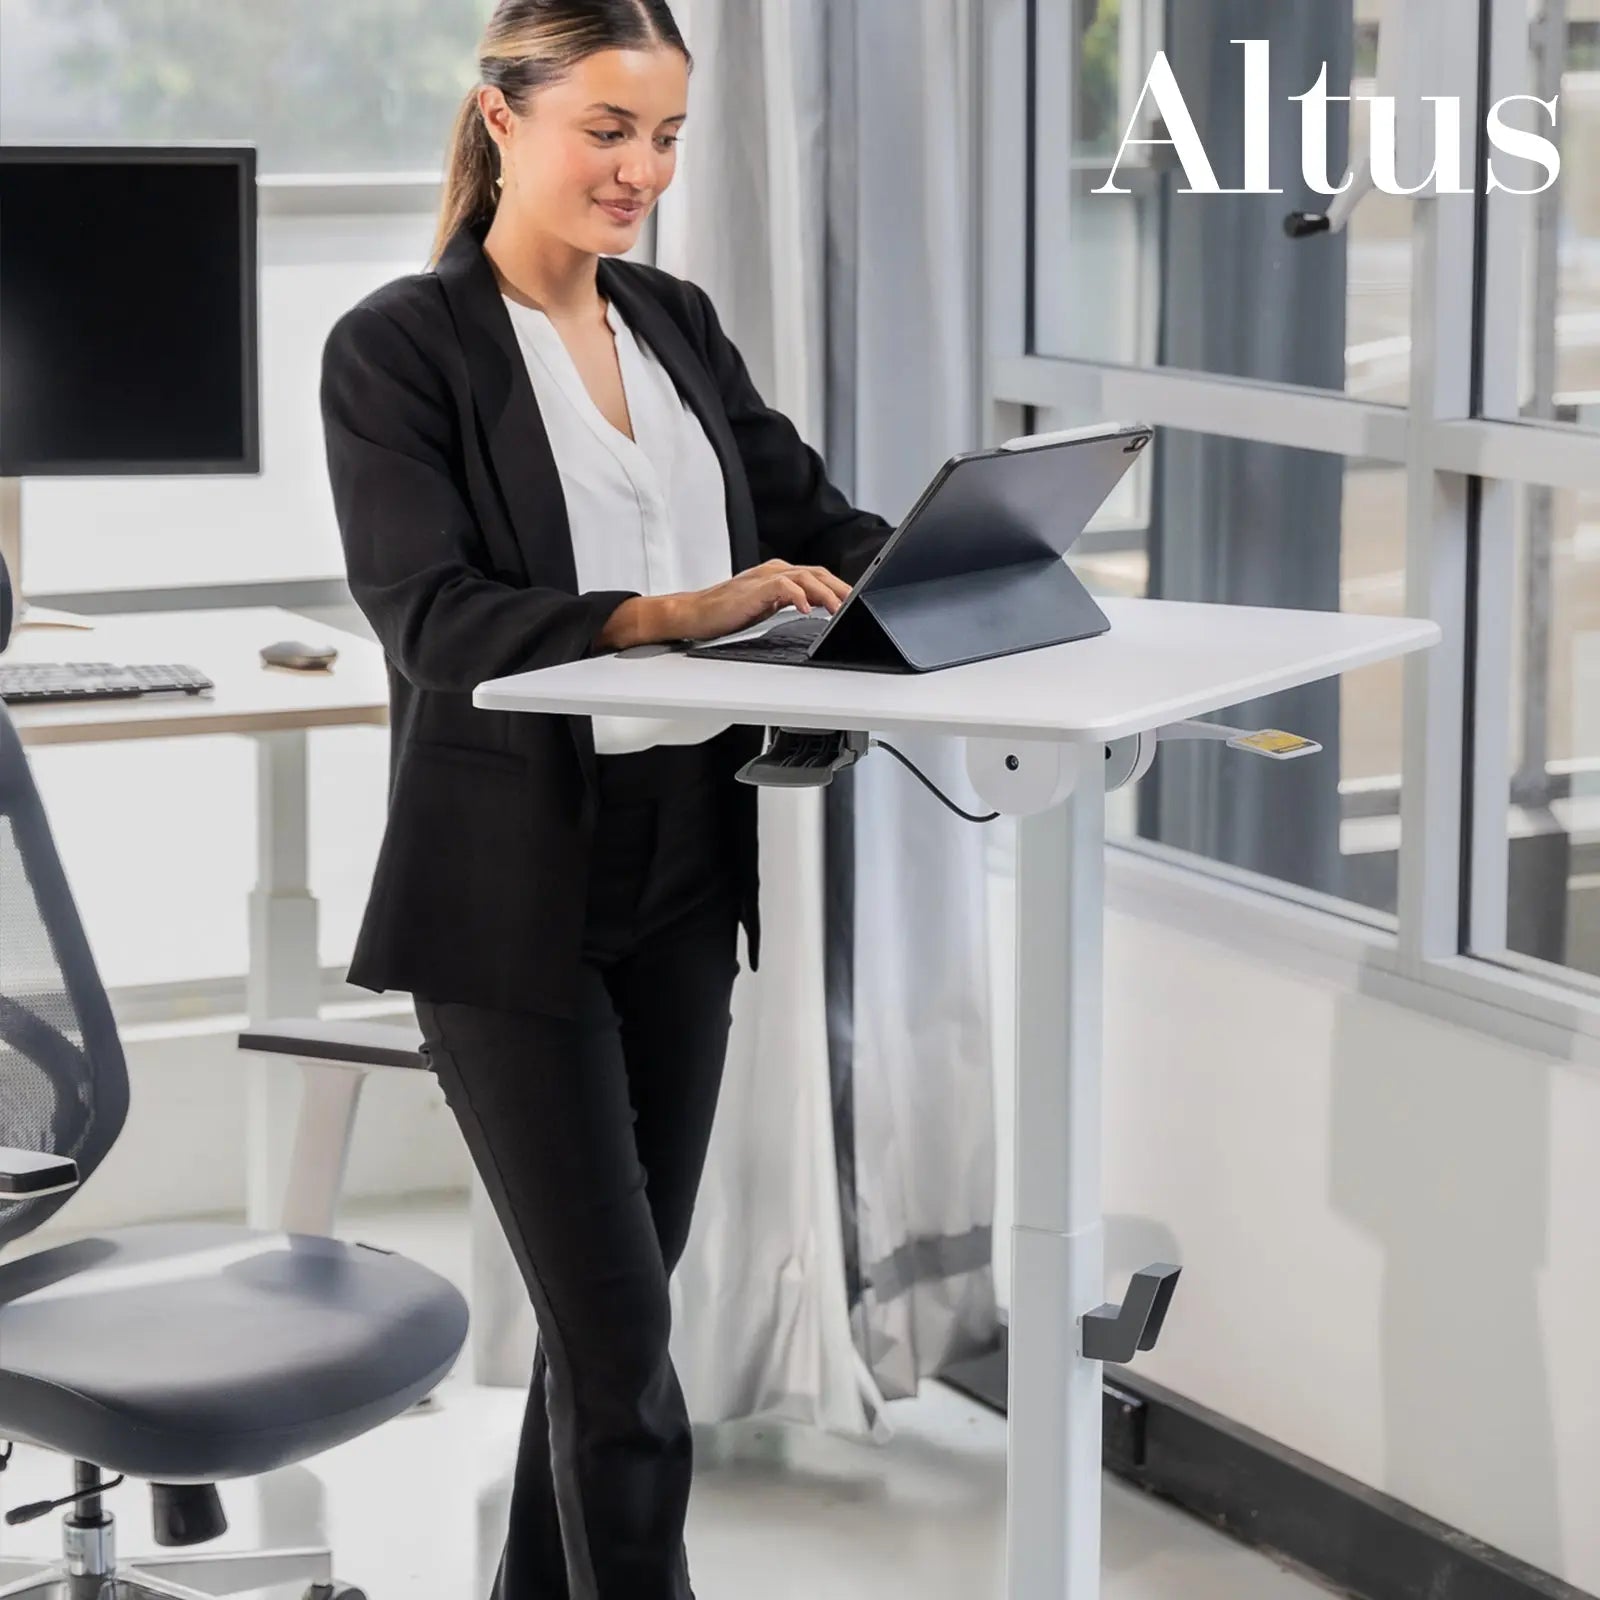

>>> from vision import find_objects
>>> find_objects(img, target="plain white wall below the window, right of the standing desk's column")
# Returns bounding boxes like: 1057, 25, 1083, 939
992, 878, 1600, 1592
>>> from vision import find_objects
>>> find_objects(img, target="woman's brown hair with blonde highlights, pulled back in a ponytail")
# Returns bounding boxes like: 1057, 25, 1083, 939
430, 0, 694, 264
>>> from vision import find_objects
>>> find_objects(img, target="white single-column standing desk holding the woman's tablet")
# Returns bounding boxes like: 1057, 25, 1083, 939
474, 600, 1440, 1600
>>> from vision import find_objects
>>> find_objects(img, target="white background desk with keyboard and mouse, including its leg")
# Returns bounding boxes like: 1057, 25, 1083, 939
3, 606, 389, 1227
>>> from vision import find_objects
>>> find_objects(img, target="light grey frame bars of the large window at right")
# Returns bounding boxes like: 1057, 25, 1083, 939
981, 0, 1600, 1043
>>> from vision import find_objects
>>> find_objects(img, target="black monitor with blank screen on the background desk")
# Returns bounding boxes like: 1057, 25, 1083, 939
0, 146, 259, 477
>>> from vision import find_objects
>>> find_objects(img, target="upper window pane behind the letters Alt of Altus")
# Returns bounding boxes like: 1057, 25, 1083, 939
1032, 0, 1411, 405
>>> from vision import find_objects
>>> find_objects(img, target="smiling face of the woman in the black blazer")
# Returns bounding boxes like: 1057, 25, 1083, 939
478, 48, 690, 256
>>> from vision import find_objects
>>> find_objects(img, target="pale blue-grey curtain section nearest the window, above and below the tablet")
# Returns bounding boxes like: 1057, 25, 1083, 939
829, 0, 997, 1397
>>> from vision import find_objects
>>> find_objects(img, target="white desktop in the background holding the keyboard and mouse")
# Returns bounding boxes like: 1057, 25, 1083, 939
0, 606, 389, 744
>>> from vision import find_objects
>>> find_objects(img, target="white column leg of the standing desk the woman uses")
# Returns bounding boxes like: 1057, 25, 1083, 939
1006, 762, 1106, 1600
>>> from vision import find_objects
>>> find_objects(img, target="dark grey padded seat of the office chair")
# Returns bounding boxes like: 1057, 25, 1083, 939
0, 1222, 467, 1483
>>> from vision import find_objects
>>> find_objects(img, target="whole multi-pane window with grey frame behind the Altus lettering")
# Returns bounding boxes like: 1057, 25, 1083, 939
986, 0, 1600, 998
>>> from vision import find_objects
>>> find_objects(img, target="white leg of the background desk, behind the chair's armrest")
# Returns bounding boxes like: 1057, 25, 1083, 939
245, 728, 322, 1227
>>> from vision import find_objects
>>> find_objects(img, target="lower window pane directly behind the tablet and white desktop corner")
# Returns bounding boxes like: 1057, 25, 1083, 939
1056, 411, 1405, 915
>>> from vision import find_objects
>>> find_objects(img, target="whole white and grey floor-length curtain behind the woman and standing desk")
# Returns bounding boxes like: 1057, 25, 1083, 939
474, 0, 997, 1437
